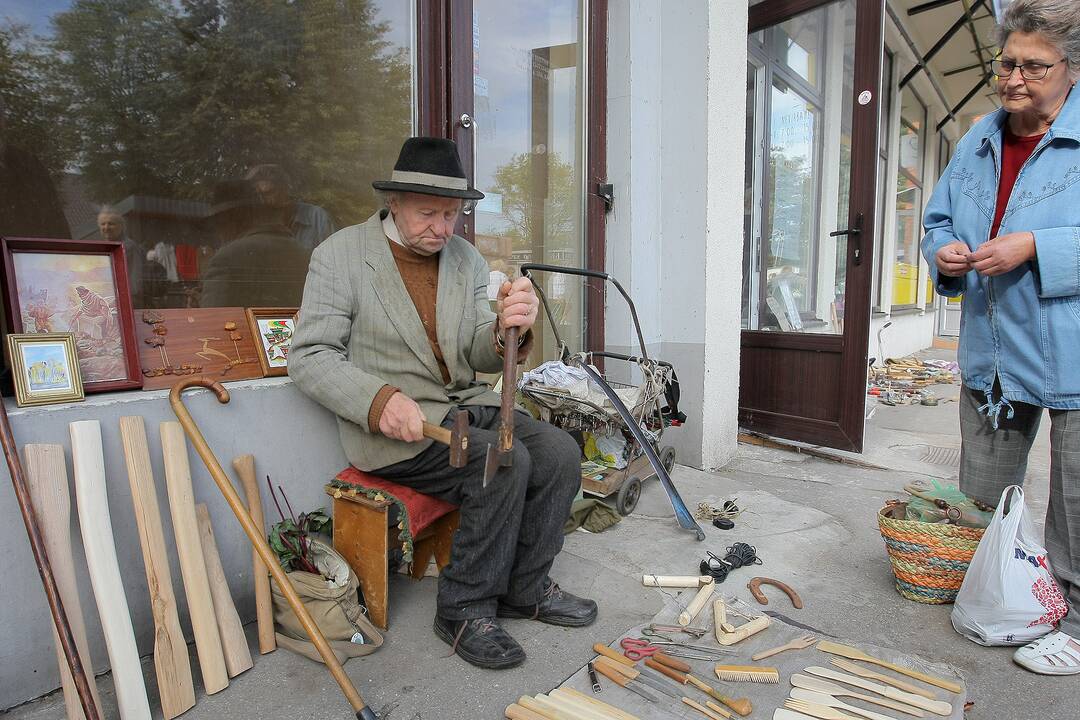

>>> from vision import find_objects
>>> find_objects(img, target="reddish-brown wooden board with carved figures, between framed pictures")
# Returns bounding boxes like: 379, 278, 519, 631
135, 308, 262, 390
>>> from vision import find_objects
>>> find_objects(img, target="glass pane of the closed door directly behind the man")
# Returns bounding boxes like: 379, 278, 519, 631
450, 0, 588, 364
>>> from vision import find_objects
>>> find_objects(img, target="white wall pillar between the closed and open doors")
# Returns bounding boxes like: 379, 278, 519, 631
606, 0, 746, 467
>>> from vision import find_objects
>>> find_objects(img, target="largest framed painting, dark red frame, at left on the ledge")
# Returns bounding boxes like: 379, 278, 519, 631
0, 237, 143, 393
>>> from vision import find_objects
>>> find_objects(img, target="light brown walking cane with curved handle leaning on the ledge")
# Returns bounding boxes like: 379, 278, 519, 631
170, 378, 378, 720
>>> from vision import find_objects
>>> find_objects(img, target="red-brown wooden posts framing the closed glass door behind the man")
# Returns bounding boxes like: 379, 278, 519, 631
416, 0, 608, 351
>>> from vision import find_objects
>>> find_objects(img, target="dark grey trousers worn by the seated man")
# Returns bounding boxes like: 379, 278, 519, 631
374, 407, 581, 621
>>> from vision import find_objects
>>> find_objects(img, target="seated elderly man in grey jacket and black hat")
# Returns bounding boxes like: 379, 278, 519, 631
288, 137, 596, 668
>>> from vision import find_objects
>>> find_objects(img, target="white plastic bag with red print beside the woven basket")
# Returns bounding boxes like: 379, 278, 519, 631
953, 485, 1068, 646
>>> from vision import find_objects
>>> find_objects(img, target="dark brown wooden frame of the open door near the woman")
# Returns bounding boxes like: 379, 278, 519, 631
739, 0, 885, 452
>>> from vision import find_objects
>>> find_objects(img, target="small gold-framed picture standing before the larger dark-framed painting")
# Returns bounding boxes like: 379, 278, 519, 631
8, 332, 84, 407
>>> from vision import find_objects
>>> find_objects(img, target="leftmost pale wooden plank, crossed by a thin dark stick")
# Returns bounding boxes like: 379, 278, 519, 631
23, 445, 102, 720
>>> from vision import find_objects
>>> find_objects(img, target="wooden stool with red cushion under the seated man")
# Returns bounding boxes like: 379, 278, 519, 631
326, 468, 459, 629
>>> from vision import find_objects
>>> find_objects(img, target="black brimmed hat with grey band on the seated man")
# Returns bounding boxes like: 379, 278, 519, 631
372, 137, 484, 200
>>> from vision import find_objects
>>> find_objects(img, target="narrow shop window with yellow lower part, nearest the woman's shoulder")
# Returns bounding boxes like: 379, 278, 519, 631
892, 87, 927, 310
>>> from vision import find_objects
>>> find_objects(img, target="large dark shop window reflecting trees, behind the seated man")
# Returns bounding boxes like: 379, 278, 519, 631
0, 0, 415, 308
